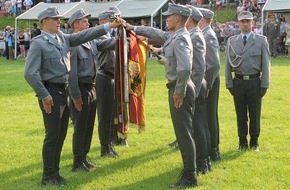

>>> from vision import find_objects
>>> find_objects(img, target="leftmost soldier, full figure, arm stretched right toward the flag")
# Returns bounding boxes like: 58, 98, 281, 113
24, 7, 120, 186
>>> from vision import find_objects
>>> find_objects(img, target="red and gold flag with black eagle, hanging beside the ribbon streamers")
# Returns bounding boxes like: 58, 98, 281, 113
129, 31, 148, 127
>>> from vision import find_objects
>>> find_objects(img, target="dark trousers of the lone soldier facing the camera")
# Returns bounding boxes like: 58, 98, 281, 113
233, 78, 262, 144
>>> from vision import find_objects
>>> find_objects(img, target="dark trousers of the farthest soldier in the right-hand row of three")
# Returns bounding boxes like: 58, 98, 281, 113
207, 75, 220, 148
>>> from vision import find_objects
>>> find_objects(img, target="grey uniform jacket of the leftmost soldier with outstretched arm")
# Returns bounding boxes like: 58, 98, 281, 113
24, 26, 107, 99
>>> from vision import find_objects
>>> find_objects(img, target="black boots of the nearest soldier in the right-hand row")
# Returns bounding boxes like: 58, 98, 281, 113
169, 171, 198, 189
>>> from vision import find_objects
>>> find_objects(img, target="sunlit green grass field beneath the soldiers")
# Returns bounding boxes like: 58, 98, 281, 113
0, 55, 290, 190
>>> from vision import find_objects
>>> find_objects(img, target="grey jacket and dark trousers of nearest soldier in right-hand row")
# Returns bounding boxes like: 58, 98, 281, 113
135, 26, 196, 172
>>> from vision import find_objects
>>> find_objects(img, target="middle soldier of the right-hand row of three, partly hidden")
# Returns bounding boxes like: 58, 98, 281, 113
186, 6, 210, 174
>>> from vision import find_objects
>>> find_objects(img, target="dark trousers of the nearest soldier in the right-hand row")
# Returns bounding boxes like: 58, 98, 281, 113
168, 82, 196, 172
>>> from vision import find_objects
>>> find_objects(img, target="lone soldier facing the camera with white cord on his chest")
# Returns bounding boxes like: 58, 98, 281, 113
225, 11, 270, 151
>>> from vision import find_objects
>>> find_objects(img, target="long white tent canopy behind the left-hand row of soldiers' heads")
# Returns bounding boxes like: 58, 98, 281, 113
15, 0, 168, 57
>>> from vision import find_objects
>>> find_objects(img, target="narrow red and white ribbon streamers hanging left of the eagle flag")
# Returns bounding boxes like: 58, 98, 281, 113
114, 27, 129, 136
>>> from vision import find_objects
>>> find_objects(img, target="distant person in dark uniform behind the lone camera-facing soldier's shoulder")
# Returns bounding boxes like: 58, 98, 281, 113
265, 15, 280, 58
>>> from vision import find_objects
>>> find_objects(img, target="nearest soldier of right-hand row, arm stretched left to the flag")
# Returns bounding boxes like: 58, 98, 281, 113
126, 3, 198, 188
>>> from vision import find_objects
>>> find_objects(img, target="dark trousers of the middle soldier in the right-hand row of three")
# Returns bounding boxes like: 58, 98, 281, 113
193, 81, 211, 159
